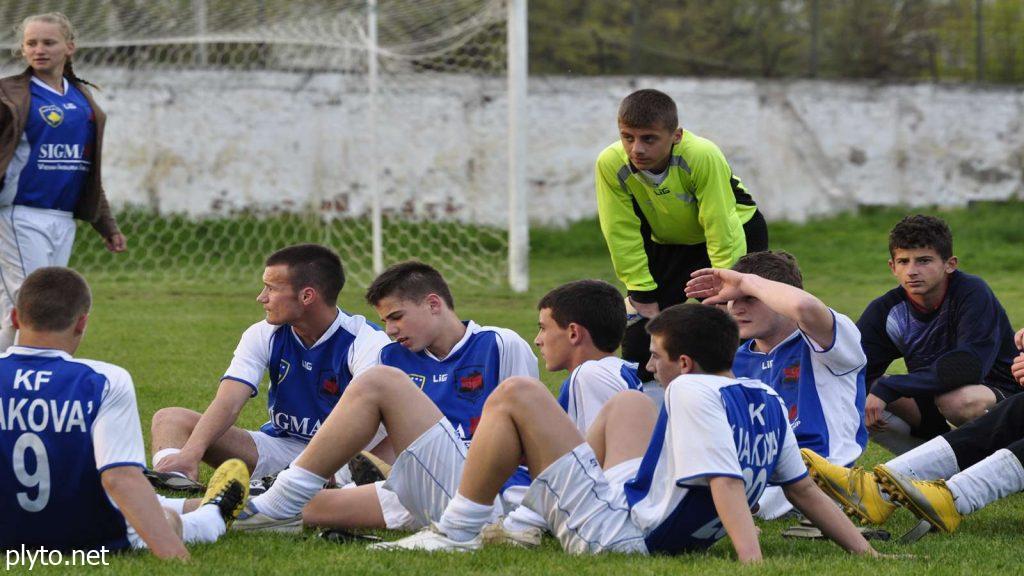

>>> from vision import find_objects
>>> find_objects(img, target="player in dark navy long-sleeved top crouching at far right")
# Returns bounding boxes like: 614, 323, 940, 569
857, 215, 1021, 454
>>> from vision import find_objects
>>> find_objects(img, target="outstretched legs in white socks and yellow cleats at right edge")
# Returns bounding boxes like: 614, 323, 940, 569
803, 330, 1024, 533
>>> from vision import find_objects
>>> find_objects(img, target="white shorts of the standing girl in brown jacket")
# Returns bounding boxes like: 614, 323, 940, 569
0, 206, 75, 328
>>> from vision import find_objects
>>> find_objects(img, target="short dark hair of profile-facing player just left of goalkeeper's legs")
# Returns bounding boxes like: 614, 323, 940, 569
537, 280, 626, 353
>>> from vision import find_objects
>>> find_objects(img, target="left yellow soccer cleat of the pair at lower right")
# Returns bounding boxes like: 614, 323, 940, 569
800, 448, 896, 524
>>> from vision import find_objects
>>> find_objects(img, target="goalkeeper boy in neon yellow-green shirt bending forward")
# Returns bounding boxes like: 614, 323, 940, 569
595, 89, 768, 380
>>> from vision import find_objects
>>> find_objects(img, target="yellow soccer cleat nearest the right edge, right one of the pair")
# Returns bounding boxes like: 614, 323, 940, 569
874, 464, 964, 534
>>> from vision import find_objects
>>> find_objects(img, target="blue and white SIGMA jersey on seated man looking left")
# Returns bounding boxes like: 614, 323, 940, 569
221, 308, 391, 441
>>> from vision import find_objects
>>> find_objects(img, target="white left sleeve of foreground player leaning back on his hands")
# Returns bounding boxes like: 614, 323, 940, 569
665, 376, 743, 486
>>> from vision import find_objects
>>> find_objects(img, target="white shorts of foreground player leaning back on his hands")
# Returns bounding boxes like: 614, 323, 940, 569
522, 443, 647, 554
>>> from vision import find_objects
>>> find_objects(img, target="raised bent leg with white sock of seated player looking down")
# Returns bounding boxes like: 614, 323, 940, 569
237, 366, 443, 528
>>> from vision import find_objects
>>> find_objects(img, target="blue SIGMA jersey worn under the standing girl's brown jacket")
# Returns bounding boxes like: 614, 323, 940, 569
0, 77, 96, 212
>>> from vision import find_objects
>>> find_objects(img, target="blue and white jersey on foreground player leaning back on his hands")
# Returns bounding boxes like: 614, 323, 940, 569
625, 374, 807, 553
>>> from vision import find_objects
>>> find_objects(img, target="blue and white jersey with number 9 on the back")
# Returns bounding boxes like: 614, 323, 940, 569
0, 346, 145, 550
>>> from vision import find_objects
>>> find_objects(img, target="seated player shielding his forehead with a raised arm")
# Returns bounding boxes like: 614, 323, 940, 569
686, 251, 867, 519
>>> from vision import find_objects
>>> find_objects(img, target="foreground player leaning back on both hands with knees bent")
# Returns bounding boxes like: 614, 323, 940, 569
374, 304, 873, 562
